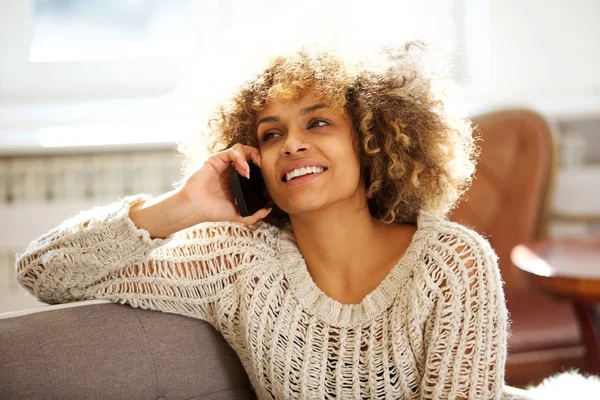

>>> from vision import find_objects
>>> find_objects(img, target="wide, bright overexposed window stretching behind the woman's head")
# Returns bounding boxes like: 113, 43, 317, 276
0, 0, 487, 99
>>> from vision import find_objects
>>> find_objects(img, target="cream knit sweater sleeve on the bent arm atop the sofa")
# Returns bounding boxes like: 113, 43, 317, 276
16, 195, 272, 324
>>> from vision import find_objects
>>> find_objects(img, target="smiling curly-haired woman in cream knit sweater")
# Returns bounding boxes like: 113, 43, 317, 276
17, 45, 524, 399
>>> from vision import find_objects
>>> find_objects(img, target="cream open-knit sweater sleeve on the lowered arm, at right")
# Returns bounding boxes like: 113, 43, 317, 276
421, 223, 507, 399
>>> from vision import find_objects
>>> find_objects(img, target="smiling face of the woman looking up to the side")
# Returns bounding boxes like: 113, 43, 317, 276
256, 93, 365, 215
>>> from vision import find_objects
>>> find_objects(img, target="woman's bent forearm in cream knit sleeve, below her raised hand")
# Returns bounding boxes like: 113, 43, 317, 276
15, 195, 168, 303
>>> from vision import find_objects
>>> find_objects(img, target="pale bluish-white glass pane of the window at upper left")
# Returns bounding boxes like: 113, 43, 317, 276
29, 0, 190, 62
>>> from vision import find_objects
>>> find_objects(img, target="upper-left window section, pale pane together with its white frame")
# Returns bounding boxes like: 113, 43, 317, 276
0, 0, 190, 101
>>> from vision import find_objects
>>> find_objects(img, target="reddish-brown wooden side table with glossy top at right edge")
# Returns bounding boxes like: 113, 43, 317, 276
511, 234, 600, 374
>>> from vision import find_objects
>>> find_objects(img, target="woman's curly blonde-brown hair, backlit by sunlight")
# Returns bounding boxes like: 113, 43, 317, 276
175, 42, 477, 228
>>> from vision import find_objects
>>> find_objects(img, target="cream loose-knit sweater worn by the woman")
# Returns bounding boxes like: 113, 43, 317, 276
17, 195, 524, 399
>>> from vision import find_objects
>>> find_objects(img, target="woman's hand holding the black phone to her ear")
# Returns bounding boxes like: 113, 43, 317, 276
181, 143, 271, 225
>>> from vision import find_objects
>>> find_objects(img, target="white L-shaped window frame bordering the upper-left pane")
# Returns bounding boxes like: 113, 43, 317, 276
0, 0, 186, 101
